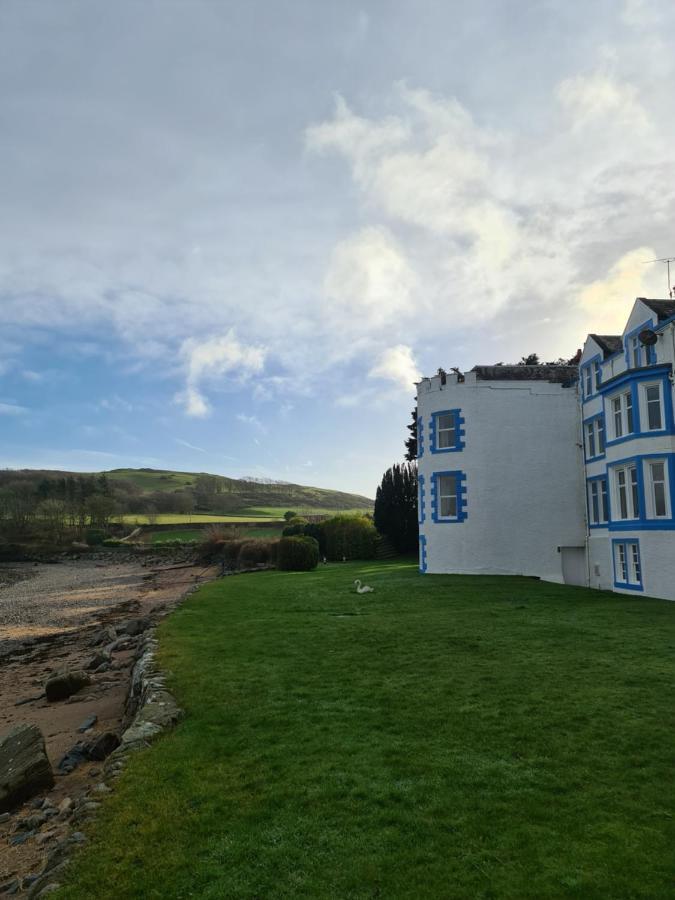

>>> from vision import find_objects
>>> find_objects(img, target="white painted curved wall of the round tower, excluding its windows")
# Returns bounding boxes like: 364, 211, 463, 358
417, 373, 586, 582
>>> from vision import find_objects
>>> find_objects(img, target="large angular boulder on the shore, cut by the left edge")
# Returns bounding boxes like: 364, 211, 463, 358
0, 725, 54, 812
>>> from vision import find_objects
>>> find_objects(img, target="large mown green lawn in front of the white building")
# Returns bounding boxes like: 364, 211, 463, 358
55, 562, 675, 900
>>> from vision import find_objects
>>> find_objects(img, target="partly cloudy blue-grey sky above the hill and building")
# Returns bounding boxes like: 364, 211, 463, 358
0, 0, 675, 497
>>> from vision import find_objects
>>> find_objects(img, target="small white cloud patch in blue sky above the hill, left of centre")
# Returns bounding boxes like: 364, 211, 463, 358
175, 329, 266, 418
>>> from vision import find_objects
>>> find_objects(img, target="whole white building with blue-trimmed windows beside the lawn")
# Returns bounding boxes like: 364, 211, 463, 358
417, 299, 675, 599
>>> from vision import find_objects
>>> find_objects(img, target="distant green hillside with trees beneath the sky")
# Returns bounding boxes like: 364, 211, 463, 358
0, 469, 373, 515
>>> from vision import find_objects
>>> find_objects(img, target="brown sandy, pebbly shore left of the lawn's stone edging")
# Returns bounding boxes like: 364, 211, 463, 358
0, 560, 214, 888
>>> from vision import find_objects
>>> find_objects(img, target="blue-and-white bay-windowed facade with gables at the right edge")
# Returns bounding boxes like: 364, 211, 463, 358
579, 298, 675, 600
